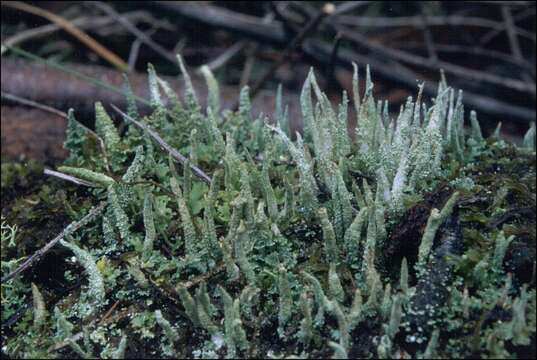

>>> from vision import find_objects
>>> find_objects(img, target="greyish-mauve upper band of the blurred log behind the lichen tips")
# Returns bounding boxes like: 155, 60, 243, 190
1, 59, 300, 119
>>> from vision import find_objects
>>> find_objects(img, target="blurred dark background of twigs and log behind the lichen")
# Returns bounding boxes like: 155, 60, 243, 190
1, 1, 536, 161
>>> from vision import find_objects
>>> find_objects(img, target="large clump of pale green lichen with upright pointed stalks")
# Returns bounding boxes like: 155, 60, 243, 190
2, 58, 535, 358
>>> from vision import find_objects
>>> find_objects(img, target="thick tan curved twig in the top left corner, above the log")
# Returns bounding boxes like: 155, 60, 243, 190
1, 1, 127, 71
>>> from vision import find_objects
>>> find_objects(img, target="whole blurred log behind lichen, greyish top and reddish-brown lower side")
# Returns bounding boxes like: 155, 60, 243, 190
1, 58, 301, 161
